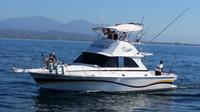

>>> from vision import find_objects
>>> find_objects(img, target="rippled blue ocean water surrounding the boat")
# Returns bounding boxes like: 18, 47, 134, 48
0, 39, 200, 112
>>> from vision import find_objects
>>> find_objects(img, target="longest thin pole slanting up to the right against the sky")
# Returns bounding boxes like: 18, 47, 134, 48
150, 8, 189, 42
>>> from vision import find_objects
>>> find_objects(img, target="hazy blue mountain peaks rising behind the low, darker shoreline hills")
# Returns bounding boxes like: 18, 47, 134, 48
0, 16, 98, 34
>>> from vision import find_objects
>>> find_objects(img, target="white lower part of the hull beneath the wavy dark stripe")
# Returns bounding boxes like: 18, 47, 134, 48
40, 82, 176, 92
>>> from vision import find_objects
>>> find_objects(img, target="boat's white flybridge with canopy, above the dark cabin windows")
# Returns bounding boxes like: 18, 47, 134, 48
86, 23, 147, 57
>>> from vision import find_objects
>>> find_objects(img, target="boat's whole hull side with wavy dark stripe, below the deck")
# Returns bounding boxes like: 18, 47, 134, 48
31, 73, 176, 92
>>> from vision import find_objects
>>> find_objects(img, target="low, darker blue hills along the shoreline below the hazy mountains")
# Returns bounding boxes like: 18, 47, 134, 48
0, 29, 97, 41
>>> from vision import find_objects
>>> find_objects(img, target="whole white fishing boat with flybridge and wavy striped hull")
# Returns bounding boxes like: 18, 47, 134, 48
13, 23, 177, 92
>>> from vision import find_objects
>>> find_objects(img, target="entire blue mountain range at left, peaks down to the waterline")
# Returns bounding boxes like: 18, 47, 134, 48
0, 16, 99, 40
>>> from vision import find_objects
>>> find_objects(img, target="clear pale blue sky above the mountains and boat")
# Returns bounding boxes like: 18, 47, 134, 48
0, 0, 200, 44
